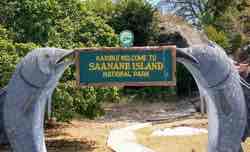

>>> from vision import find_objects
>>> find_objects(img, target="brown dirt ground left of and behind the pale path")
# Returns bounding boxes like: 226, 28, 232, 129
0, 102, 199, 152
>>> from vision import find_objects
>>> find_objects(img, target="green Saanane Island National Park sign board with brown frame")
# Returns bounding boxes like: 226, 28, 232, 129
76, 47, 176, 86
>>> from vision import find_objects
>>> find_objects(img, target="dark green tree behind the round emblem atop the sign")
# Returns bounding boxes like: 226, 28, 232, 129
109, 0, 159, 46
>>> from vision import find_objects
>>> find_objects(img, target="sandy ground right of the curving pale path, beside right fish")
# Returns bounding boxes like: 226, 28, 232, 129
136, 115, 250, 152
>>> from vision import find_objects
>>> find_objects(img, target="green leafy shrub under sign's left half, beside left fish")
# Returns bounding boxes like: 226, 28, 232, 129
52, 81, 119, 121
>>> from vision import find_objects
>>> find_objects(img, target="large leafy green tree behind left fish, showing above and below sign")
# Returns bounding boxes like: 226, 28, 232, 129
0, 0, 119, 121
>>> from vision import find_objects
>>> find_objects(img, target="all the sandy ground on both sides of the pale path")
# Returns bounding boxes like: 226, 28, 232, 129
0, 102, 250, 152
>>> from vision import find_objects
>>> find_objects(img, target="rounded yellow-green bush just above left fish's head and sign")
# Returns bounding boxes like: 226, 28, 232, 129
48, 15, 118, 48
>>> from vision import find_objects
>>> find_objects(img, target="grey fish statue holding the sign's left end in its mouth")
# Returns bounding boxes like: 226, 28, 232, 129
0, 48, 73, 152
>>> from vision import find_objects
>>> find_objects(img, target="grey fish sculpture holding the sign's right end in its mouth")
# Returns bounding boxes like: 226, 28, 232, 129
176, 42, 247, 152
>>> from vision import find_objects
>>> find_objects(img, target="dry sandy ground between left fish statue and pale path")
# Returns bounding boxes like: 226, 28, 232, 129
46, 120, 127, 152
